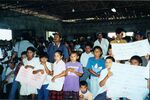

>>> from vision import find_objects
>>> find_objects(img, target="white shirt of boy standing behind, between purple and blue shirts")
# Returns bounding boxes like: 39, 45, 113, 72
80, 52, 94, 67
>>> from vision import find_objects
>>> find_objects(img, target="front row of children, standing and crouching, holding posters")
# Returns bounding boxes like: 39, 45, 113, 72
0, 46, 149, 100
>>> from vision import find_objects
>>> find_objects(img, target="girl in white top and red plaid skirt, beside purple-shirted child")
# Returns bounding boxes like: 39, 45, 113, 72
47, 50, 66, 100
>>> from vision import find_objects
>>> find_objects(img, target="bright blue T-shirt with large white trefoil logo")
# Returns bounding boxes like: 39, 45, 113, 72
86, 57, 105, 75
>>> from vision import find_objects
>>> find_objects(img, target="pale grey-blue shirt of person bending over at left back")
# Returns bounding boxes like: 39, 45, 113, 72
14, 40, 34, 58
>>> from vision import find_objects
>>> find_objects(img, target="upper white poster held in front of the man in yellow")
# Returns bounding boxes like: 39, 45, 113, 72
112, 39, 150, 60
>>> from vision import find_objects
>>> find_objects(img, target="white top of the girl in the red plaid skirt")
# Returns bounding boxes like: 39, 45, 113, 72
47, 60, 66, 91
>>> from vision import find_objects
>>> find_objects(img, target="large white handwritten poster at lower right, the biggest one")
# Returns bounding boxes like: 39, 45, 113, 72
106, 63, 149, 100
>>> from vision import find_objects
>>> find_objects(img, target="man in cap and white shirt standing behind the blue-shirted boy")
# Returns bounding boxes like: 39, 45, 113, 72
94, 32, 109, 57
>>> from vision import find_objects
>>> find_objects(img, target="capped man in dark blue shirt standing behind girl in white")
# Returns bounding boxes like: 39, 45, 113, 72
47, 32, 69, 63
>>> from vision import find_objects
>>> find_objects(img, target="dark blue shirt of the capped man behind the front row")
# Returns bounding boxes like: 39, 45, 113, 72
47, 43, 69, 63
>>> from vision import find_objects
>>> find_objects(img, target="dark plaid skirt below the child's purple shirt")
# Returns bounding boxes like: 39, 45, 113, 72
63, 91, 79, 100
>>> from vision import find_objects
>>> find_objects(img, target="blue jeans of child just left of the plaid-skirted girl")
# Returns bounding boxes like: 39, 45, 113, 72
38, 84, 49, 100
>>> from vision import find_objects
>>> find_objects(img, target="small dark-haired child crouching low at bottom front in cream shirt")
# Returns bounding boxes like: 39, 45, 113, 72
79, 81, 93, 100
